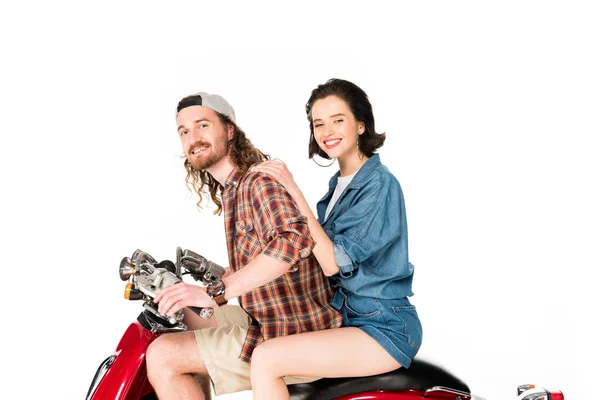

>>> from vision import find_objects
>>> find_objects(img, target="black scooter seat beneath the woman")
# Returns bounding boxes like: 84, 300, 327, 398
288, 360, 470, 400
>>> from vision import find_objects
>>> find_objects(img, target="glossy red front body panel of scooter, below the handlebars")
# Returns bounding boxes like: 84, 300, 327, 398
86, 322, 160, 400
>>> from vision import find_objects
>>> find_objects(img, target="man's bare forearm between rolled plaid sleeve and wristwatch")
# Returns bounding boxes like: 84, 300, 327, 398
223, 254, 291, 300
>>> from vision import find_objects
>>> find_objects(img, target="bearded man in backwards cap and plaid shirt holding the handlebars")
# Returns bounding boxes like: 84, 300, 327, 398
146, 92, 341, 399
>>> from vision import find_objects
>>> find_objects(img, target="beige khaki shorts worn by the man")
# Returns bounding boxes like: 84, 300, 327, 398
194, 305, 320, 396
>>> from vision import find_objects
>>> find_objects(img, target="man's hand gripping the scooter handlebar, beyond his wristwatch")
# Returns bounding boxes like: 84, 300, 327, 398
154, 282, 217, 317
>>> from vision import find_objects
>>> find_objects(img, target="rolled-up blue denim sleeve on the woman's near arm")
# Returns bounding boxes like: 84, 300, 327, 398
332, 174, 403, 278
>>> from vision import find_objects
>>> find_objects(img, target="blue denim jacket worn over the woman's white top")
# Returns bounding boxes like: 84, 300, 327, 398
317, 154, 414, 309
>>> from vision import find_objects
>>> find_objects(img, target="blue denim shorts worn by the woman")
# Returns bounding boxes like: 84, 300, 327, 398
340, 293, 423, 368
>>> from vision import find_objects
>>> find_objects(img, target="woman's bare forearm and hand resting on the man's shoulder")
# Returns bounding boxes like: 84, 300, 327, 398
252, 161, 340, 276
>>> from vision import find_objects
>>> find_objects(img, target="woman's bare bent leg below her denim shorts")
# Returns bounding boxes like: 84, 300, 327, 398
251, 327, 400, 400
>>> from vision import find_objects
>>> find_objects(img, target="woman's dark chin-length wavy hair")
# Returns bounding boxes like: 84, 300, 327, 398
306, 78, 385, 160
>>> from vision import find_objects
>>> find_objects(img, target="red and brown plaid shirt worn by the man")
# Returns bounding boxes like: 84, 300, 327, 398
221, 169, 342, 362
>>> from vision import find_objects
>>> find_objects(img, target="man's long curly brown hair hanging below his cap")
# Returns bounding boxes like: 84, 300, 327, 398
182, 112, 270, 215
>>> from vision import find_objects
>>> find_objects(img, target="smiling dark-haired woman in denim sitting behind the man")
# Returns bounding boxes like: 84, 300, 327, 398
251, 79, 422, 400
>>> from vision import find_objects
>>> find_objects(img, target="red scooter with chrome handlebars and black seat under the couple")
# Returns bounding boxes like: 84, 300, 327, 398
86, 248, 564, 400
